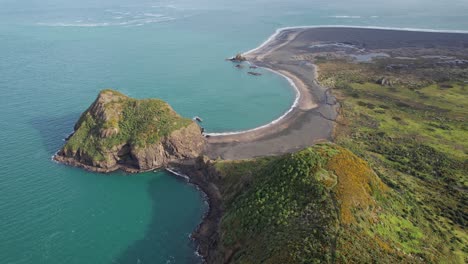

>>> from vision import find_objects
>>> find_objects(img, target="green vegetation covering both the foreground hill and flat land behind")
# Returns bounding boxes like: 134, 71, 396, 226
198, 41, 468, 263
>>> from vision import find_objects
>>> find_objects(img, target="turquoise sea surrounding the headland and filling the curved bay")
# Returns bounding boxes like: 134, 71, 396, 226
0, 0, 468, 263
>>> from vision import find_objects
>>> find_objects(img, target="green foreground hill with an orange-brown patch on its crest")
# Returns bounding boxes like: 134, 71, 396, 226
206, 144, 436, 263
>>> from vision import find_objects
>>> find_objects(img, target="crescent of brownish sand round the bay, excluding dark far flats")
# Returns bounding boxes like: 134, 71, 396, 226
206, 27, 338, 159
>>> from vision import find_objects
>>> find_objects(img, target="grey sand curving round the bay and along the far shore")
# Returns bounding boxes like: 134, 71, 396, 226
205, 27, 468, 160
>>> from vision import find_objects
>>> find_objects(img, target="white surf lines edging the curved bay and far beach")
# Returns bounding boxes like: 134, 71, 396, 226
205, 25, 468, 137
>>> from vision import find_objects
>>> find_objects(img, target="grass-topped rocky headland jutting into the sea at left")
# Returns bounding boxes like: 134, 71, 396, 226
54, 90, 205, 172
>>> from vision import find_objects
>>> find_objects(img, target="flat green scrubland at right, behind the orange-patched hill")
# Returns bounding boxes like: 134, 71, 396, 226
318, 59, 468, 263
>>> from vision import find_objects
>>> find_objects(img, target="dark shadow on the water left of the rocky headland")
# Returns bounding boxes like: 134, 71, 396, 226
31, 113, 80, 155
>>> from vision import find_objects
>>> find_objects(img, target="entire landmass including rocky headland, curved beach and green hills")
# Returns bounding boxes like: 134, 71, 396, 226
55, 28, 468, 263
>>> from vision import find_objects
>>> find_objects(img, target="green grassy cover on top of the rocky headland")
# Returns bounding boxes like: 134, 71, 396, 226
64, 89, 192, 160
